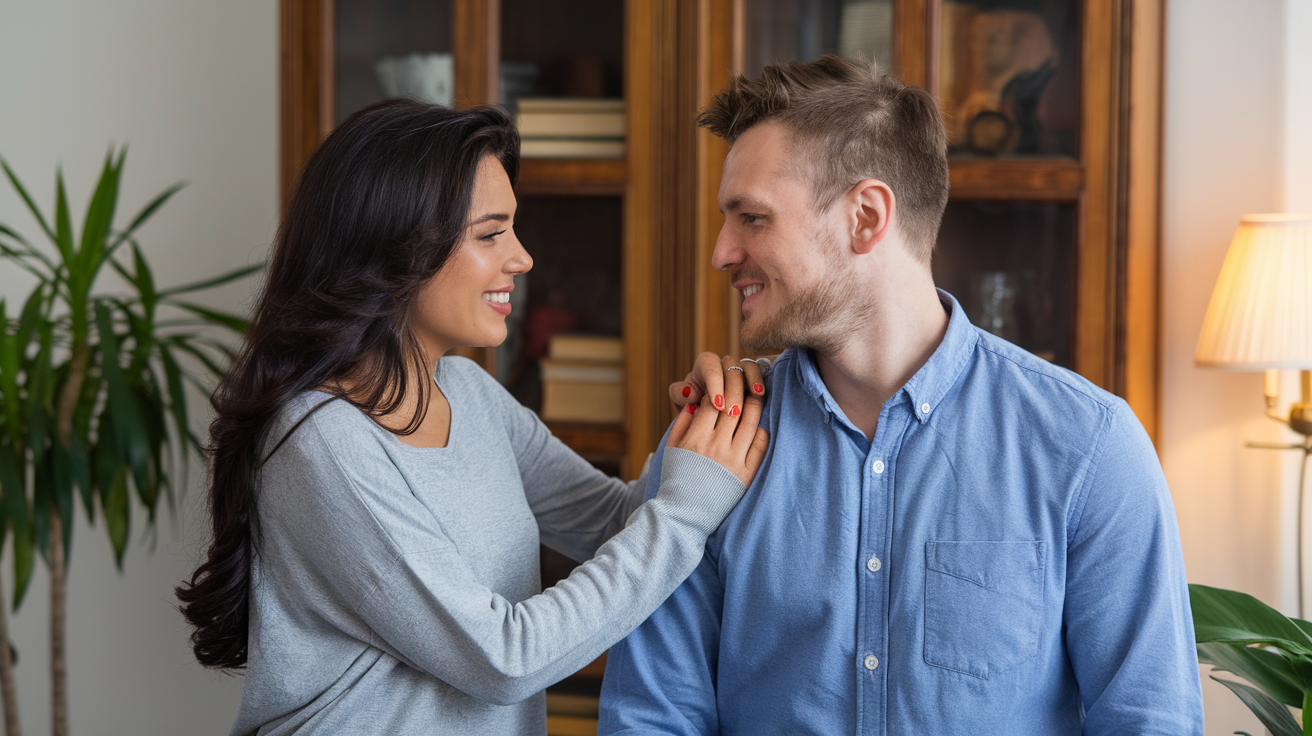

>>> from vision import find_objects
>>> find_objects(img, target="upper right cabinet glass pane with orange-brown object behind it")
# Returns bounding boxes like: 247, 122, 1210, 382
938, 0, 1080, 156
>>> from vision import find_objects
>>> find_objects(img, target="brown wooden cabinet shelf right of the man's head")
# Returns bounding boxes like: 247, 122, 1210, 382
947, 156, 1084, 202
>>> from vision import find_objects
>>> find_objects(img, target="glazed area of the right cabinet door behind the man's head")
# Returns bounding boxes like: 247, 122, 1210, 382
744, 0, 1081, 366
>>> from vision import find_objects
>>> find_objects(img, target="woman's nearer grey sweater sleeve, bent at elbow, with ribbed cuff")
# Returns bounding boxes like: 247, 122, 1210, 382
261, 401, 745, 705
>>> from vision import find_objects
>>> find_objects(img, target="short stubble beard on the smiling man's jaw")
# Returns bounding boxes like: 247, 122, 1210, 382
740, 229, 870, 356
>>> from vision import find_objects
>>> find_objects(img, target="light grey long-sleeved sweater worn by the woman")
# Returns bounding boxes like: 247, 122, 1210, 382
232, 358, 745, 736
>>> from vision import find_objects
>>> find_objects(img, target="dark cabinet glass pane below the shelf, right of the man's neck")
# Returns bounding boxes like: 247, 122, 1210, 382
934, 202, 1076, 367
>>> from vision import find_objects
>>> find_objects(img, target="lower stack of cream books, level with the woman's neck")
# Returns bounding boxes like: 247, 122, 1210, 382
541, 335, 625, 424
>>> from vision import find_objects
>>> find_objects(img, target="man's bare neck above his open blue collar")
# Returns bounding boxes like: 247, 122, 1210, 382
816, 263, 949, 440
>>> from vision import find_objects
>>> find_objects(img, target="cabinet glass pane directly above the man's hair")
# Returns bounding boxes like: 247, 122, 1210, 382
745, 0, 893, 77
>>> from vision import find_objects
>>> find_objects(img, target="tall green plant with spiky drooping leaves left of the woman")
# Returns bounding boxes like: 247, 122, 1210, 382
0, 148, 261, 736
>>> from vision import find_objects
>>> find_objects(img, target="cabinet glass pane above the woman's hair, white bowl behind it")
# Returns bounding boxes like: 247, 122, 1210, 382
335, 0, 455, 122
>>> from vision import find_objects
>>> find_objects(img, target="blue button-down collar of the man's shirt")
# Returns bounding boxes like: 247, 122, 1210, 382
796, 289, 979, 424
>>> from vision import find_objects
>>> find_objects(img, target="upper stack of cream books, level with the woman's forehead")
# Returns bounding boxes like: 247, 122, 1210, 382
516, 97, 625, 159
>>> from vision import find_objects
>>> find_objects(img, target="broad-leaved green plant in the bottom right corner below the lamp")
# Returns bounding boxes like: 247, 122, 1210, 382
1189, 585, 1312, 736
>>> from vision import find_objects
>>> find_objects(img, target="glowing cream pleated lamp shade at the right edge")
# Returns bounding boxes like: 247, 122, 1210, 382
1194, 215, 1312, 370
